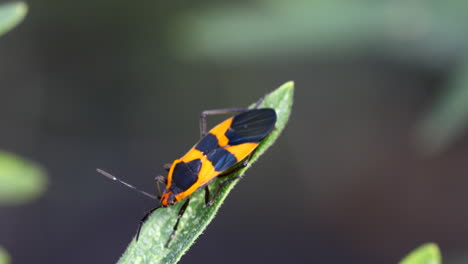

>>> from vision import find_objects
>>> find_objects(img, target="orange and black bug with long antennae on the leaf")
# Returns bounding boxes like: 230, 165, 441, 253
97, 97, 277, 247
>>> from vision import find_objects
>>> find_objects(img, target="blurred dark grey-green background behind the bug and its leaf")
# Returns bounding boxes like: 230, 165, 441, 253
0, 0, 468, 264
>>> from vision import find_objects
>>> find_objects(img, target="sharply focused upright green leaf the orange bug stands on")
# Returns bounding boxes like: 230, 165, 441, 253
119, 82, 294, 264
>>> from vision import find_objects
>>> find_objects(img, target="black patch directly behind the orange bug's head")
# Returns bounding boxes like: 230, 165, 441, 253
171, 159, 201, 194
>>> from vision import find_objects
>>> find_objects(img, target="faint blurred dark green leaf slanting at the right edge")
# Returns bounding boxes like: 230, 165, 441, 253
415, 64, 468, 154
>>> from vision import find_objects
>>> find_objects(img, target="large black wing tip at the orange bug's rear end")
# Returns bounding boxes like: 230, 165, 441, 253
226, 108, 276, 146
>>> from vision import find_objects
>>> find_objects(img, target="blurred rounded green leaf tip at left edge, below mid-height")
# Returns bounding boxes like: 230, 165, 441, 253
0, 151, 47, 205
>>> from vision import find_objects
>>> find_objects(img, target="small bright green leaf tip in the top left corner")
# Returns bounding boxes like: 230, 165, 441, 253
0, 2, 28, 36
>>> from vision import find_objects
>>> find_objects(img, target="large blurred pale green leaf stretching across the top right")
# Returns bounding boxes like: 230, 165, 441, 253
170, 0, 468, 65
